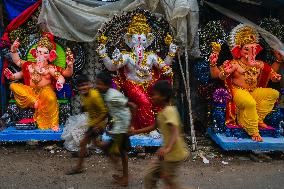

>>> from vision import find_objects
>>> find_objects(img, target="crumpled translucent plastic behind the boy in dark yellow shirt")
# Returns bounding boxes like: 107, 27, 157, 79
61, 113, 88, 151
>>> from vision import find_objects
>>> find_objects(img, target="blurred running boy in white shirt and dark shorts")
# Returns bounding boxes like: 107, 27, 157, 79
96, 72, 135, 186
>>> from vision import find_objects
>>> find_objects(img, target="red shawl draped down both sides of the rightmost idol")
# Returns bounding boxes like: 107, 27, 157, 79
225, 62, 271, 124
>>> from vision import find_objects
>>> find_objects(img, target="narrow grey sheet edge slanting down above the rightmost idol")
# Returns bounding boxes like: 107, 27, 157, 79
205, 1, 284, 56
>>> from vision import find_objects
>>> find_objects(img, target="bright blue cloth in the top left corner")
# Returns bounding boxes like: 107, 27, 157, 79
3, 0, 38, 20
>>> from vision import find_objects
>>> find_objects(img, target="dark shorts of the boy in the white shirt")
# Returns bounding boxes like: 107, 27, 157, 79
106, 133, 131, 156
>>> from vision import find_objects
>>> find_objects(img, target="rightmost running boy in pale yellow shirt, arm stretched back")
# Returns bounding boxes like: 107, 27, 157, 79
130, 81, 189, 189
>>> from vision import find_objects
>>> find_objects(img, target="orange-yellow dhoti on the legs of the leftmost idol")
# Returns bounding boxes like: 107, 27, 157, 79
10, 83, 59, 129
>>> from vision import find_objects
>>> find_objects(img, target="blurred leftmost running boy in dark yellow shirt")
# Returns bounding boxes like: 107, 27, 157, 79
66, 75, 108, 175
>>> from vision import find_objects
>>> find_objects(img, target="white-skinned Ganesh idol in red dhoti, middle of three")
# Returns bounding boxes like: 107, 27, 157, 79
98, 14, 177, 129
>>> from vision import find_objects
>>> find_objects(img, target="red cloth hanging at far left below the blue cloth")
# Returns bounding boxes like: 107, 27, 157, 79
1, 0, 42, 84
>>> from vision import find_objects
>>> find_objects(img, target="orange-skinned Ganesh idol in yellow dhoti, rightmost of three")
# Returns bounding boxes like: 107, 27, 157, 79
209, 24, 283, 142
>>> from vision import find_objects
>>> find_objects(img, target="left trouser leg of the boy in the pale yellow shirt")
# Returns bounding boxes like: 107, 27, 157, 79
144, 160, 162, 189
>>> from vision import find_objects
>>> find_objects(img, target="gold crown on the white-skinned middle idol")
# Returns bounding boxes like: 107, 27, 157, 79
127, 13, 151, 34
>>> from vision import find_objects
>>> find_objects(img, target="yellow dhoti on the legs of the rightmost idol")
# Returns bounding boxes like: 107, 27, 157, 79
233, 88, 279, 136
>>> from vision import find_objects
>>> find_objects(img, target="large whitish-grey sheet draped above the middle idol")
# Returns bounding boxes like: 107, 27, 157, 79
38, 0, 199, 56
